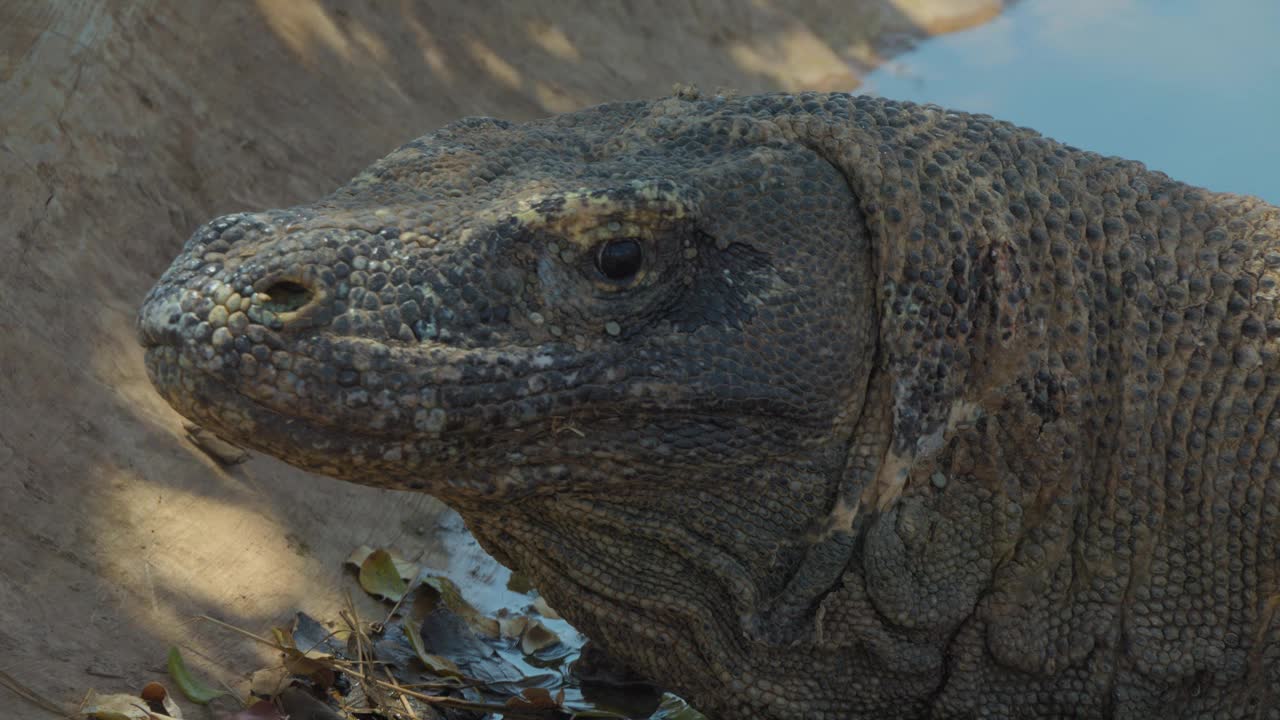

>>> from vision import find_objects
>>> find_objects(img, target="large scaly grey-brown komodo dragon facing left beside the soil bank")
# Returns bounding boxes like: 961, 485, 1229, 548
140, 94, 1280, 719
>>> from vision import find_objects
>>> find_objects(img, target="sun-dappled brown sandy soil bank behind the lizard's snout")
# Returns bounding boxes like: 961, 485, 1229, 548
0, 0, 1000, 717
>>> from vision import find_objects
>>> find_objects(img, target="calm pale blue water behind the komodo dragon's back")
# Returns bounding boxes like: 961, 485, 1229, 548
858, 0, 1280, 204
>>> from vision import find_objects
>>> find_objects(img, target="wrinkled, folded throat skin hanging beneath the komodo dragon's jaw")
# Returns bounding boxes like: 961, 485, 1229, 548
460, 430, 929, 717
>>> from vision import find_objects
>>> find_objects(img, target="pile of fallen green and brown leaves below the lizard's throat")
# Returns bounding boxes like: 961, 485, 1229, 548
67, 547, 704, 720
